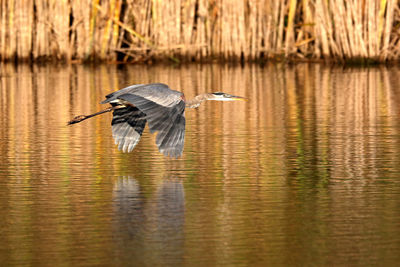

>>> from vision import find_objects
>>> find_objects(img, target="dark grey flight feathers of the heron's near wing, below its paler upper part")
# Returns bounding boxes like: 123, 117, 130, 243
118, 93, 186, 158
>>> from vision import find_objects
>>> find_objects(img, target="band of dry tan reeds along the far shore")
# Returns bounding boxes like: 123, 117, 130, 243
0, 0, 400, 63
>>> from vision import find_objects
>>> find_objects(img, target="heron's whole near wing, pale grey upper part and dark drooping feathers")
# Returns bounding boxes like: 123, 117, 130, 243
102, 84, 185, 158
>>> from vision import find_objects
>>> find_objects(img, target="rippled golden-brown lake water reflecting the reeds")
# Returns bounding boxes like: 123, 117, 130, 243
0, 64, 400, 266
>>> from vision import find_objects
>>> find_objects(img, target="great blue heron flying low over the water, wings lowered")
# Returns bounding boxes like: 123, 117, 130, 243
68, 83, 245, 158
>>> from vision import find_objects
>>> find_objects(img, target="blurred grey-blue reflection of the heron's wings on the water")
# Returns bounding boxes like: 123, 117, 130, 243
113, 177, 185, 265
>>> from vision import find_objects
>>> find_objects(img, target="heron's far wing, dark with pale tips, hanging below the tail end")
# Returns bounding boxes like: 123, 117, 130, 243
111, 106, 146, 152
